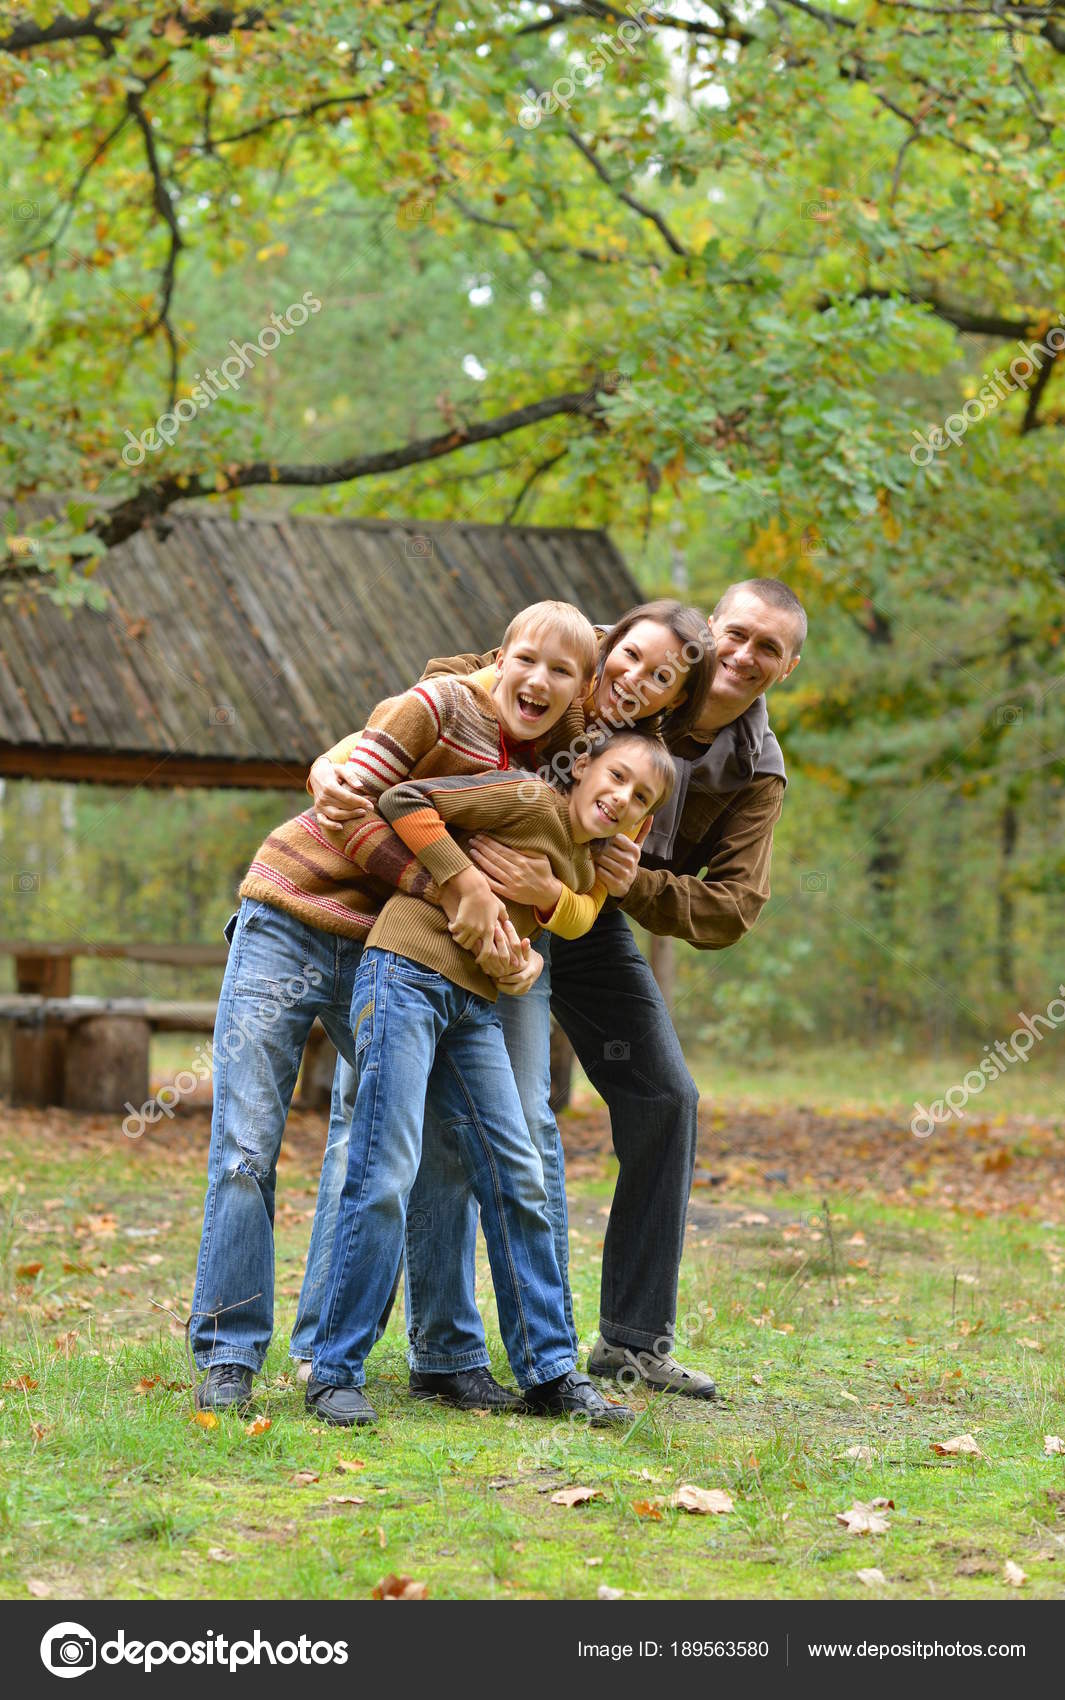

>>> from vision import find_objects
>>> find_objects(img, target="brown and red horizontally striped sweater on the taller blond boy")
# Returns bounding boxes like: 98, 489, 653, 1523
240, 678, 580, 938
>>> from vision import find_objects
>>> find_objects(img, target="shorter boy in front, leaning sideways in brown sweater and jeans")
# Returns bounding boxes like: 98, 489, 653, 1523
306, 733, 674, 1426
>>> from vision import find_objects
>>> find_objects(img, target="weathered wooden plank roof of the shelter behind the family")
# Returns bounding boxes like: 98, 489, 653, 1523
0, 508, 640, 789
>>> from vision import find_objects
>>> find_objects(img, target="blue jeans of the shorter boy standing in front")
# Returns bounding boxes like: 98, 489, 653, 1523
313, 949, 577, 1387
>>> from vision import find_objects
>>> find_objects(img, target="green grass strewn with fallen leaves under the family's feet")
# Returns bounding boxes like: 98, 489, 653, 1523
0, 1110, 1065, 1600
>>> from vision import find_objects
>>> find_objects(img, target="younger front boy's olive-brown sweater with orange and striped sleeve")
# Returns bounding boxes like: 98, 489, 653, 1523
367, 768, 595, 1003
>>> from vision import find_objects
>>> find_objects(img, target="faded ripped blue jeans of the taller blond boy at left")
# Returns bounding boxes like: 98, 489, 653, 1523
192, 898, 362, 1370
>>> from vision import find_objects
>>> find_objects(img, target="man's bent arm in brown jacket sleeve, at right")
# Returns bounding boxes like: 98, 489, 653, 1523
621, 777, 784, 950
